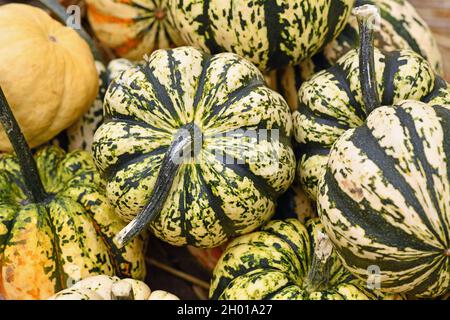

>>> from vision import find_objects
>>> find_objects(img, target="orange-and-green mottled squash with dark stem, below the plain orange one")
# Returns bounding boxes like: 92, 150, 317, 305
0, 89, 145, 299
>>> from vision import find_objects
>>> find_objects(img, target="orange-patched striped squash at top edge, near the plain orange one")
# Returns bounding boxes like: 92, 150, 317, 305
86, 0, 183, 60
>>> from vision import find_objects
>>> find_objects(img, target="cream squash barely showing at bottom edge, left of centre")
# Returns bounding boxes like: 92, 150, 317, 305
49, 275, 179, 300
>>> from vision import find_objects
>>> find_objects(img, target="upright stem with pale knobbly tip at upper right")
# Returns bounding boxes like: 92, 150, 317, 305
353, 5, 381, 115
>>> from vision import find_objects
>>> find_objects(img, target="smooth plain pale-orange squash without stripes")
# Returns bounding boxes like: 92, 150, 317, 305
0, 4, 98, 151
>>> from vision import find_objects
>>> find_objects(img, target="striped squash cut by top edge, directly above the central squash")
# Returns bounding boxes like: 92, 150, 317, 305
168, 0, 354, 70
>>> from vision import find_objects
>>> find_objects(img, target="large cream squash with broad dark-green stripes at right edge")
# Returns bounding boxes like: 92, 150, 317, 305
318, 100, 450, 298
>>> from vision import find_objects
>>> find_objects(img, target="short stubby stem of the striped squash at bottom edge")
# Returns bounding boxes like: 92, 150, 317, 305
304, 231, 333, 293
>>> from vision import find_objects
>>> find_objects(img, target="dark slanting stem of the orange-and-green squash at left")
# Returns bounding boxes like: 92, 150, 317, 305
0, 87, 47, 203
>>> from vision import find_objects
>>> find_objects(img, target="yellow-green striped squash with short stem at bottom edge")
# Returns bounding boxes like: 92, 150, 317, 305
210, 218, 394, 300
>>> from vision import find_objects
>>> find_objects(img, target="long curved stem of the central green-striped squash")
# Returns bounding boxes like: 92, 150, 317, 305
115, 123, 198, 248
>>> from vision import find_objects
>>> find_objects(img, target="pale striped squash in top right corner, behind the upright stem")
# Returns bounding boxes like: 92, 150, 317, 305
277, 0, 443, 110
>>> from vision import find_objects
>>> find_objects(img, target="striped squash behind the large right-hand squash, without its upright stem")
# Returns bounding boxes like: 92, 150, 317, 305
293, 5, 450, 199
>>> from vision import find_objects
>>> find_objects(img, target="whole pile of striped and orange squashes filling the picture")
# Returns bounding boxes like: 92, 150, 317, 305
0, 0, 450, 300
